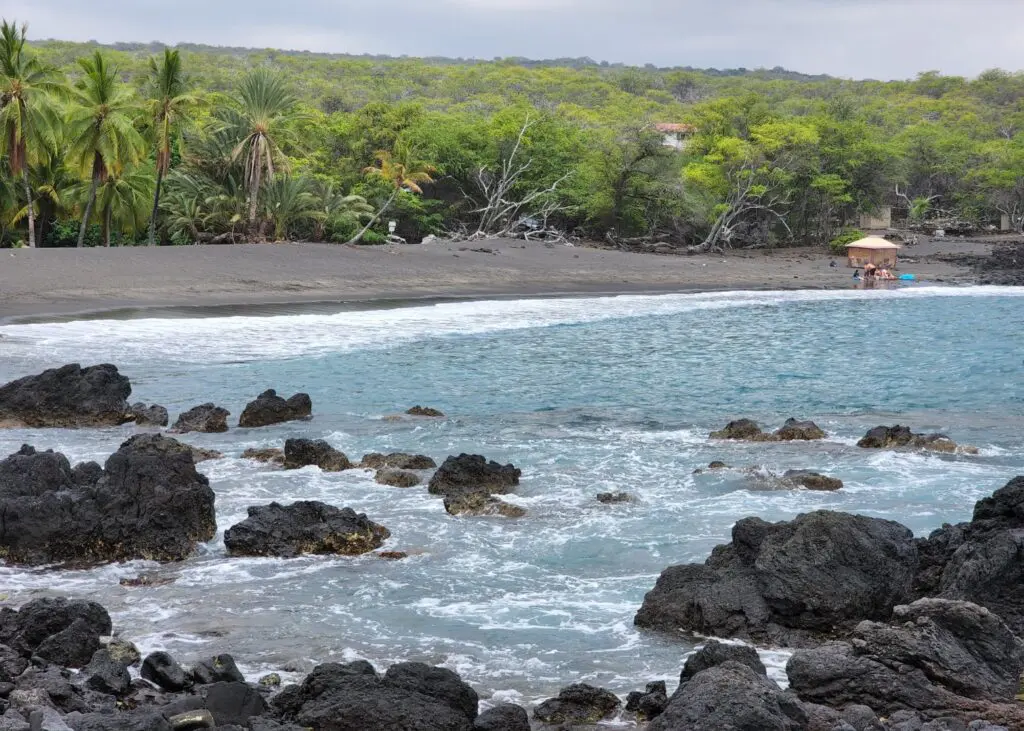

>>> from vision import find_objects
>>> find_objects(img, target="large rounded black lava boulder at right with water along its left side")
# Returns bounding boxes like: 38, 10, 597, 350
634, 511, 919, 647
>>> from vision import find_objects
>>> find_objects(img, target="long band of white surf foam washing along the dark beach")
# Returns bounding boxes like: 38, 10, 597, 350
0, 287, 1024, 364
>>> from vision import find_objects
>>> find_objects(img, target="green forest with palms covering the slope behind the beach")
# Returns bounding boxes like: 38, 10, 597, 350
0, 20, 1024, 251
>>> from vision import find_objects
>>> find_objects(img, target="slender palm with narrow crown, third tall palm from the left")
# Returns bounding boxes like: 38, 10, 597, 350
150, 48, 198, 246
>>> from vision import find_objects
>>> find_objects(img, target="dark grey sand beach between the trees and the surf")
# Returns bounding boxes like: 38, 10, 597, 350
0, 241, 988, 321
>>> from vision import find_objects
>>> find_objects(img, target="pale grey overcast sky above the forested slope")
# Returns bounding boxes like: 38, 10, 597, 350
8, 0, 1024, 79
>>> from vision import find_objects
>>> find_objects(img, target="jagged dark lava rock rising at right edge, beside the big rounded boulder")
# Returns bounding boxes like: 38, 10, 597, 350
915, 477, 1024, 637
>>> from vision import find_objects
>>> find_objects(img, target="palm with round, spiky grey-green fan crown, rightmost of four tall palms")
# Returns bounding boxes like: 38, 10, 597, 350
215, 69, 296, 233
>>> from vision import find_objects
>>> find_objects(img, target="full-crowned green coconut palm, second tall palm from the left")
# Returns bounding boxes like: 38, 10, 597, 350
68, 51, 145, 247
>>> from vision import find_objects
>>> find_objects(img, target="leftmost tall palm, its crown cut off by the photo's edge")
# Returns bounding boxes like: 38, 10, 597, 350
0, 20, 60, 247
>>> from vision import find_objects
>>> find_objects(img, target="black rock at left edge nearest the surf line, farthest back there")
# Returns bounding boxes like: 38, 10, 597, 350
0, 363, 132, 429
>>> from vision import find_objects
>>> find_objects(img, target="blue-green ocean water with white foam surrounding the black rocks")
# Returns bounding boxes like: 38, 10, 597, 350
0, 288, 1024, 703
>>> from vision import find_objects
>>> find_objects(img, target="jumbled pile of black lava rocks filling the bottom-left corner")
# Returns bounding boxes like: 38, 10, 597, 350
0, 599, 507, 731
